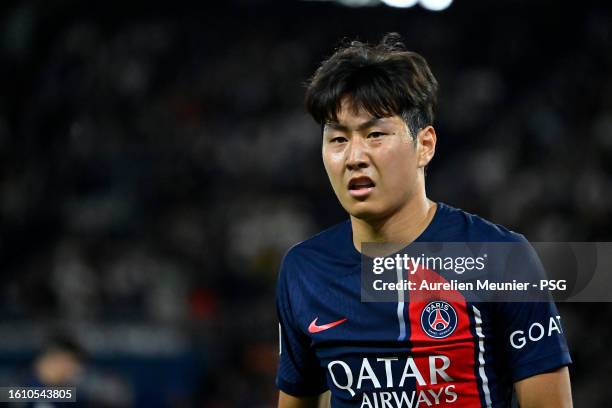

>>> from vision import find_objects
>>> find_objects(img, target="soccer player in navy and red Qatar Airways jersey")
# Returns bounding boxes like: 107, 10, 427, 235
276, 34, 572, 408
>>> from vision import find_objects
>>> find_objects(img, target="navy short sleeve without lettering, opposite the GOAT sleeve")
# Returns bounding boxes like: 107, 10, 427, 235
276, 253, 327, 397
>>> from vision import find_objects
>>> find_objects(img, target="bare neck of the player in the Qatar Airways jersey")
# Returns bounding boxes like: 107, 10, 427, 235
351, 197, 437, 252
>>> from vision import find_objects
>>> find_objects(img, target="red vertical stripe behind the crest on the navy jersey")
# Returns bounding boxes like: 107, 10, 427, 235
408, 269, 481, 408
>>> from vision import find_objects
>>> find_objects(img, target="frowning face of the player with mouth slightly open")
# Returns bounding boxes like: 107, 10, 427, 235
322, 99, 422, 221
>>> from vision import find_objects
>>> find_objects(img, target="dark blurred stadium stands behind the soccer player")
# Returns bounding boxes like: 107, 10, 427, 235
0, 0, 612, 407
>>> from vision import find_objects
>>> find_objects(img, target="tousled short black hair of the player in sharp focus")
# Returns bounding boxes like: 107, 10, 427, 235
305, 33, 438, 137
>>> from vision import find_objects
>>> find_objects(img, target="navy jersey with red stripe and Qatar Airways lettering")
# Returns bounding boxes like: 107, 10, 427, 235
276, 203, 571, 408
